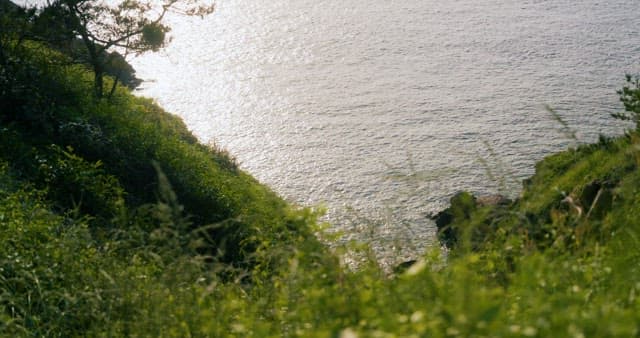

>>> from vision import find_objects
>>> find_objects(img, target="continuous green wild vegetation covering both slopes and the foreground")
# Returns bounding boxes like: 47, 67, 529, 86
0, 1, 640, 337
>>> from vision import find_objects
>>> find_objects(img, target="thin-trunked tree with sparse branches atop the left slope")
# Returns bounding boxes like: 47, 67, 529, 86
41, 0, 214, 99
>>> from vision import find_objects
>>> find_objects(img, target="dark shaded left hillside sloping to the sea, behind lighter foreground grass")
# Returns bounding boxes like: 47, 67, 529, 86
0, 0, 322, 263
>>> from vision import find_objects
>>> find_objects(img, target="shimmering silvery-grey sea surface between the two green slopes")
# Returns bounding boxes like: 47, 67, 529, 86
133, 0, 640, 257
